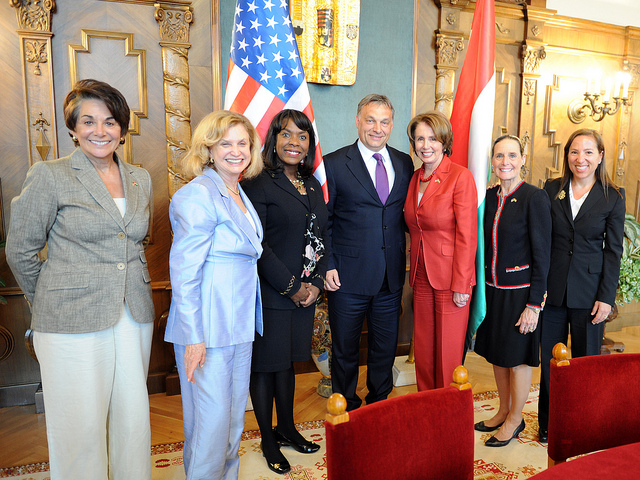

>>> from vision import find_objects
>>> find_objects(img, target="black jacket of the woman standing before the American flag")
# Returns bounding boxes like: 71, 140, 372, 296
242, 171, 328, 309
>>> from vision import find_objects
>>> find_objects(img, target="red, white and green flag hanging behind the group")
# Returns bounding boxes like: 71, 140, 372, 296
451, 0, 496, 340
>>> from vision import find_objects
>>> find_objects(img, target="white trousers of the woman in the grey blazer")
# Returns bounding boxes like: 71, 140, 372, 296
33, 304, 153, 480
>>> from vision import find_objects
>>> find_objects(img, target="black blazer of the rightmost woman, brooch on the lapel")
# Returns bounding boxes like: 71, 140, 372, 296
544, 178, 625, 309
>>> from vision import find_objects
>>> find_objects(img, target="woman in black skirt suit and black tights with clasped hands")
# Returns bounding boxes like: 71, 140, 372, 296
243, 110, 328, 474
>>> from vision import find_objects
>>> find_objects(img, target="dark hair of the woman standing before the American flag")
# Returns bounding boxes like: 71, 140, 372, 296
262, 110, 316, 178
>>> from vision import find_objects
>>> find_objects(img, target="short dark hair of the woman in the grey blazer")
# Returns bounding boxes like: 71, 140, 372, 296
64, 78, 131, 144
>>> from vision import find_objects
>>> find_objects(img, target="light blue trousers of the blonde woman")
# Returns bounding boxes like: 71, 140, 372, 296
174, 342, 253, 480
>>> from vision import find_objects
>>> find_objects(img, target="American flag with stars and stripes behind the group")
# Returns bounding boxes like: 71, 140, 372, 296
224, 0, 328, 201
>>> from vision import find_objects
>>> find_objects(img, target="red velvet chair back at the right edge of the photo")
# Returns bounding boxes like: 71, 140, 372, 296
549, 343, 640, 466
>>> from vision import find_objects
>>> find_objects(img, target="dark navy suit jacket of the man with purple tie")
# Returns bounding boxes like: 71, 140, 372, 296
324, 142, 413, 295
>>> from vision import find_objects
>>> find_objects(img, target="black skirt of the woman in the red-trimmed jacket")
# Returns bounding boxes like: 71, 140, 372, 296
474, 286, 541, 368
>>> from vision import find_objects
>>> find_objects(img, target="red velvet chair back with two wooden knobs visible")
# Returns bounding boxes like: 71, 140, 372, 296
325, 366, 474, 480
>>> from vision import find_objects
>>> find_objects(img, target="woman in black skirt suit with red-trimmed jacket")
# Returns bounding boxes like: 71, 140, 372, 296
475, 135, 551, 447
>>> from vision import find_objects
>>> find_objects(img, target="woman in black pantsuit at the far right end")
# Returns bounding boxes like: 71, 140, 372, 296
538, 129, 625, 441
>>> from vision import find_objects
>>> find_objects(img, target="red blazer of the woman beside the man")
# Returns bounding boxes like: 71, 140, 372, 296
404, 156, 478, 294
